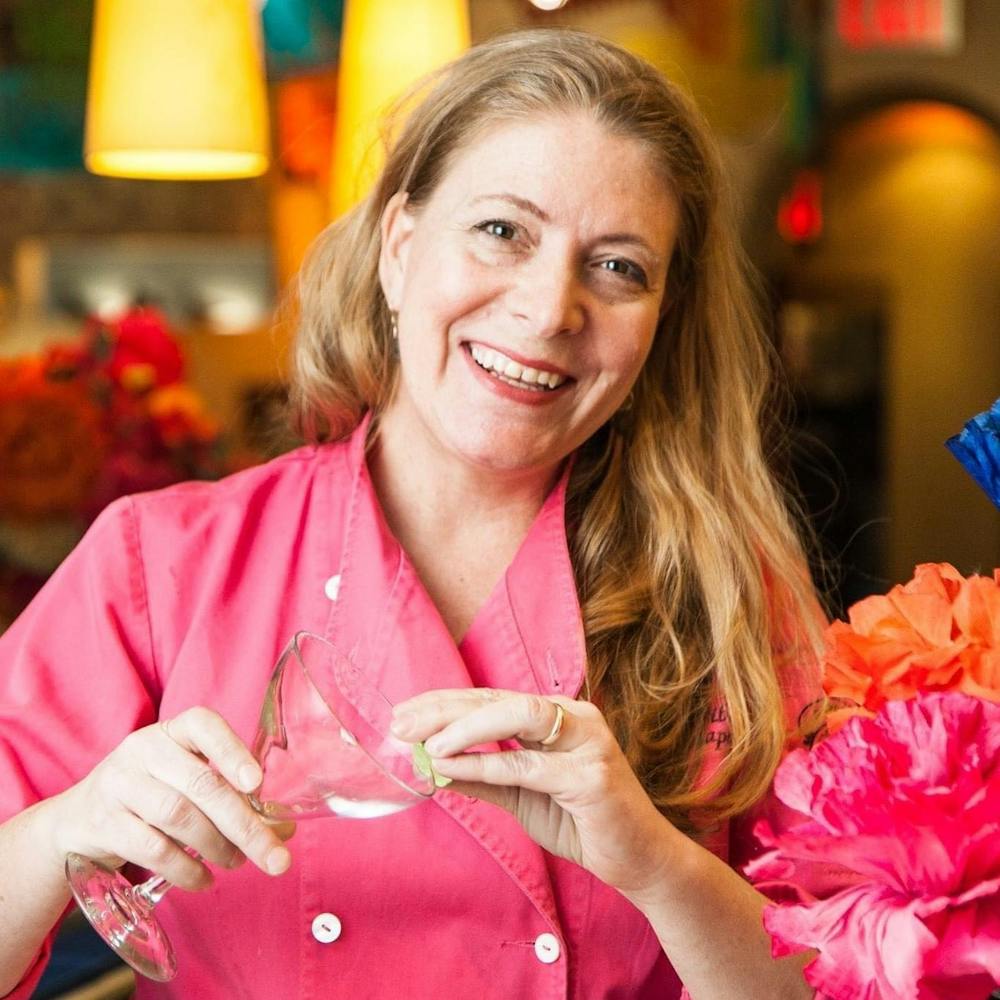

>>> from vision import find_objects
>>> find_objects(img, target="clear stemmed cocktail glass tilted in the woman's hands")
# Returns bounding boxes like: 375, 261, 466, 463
66, 632, 435, 982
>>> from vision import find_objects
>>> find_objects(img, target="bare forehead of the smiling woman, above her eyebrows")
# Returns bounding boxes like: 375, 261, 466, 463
430, 112, 675, 236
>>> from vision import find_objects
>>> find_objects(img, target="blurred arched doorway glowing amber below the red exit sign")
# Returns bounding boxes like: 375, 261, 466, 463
769, 100, 1000, 599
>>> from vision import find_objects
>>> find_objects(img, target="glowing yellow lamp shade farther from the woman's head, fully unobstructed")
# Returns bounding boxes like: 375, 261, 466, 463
84, 0, 269, 180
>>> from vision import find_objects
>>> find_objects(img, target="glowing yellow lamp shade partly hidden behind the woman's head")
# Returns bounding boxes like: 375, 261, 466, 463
330, 0, 469, 217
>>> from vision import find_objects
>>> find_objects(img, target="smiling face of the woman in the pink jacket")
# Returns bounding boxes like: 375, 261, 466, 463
380, 113, 678, 480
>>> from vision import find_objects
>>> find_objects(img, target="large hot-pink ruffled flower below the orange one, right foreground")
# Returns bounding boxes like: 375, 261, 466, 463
746, 692, 1000, 1000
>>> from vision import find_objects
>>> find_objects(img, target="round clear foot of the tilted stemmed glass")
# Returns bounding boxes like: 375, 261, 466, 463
66, 854, 177, 983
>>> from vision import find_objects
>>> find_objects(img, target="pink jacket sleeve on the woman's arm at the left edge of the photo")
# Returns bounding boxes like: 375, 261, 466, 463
0, 499, 158, 1000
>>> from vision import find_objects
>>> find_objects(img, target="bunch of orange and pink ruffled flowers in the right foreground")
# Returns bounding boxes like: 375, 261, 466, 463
745, 563, 1000, 1000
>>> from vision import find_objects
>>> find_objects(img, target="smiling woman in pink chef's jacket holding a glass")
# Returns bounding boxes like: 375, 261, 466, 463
0, 32, 813, 1000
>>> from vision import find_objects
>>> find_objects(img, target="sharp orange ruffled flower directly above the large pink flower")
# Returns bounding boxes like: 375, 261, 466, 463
823, 563, 1000, 729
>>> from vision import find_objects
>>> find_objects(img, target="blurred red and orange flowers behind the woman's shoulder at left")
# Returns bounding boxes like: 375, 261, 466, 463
0, 308, 227, 522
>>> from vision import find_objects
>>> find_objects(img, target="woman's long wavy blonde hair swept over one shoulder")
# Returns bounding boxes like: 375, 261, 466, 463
292, 30, 817, 829
